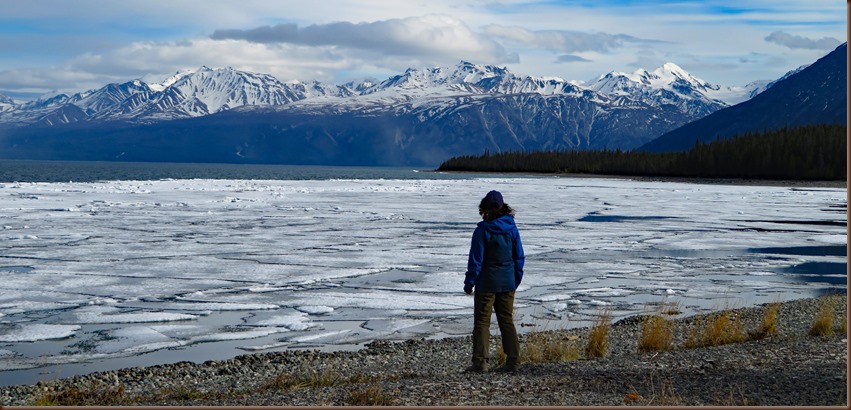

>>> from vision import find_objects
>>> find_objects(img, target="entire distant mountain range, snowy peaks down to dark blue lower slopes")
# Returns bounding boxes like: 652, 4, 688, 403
0, 52, 828, 166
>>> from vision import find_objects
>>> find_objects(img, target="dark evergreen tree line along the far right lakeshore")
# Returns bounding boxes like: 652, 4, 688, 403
438, 124, 848, 180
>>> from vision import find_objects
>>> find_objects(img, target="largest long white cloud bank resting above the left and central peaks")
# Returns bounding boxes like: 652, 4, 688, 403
11, 15, 517, 91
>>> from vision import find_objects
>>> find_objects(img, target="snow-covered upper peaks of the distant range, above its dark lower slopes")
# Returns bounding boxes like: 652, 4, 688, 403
0, 62, 760, 125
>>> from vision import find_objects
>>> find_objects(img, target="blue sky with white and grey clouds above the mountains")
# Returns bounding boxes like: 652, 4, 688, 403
0, 0, 847, 98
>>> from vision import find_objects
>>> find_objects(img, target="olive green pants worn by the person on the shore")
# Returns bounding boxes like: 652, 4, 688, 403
473, 292, 520, 368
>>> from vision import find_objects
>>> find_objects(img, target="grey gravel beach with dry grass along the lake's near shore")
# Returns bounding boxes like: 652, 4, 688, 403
0, 295, 848, 407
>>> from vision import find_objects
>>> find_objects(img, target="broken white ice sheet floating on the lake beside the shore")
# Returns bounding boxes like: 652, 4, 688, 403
0, 177, 847, 385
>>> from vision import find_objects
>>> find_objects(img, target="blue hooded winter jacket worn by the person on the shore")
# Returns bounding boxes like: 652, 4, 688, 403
464, 215, 526, 293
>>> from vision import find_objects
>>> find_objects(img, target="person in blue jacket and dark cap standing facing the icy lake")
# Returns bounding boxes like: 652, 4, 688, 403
464, 191, 526, 372
